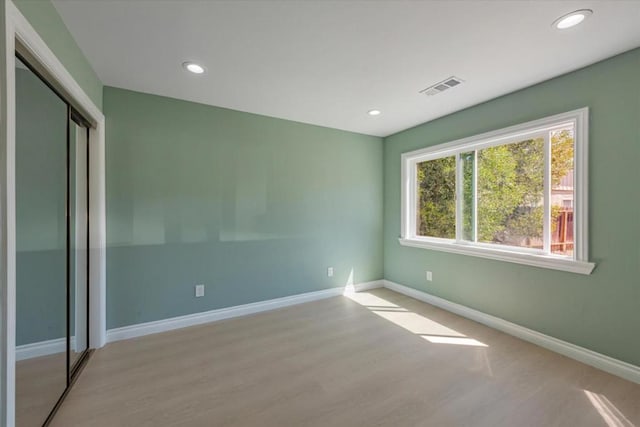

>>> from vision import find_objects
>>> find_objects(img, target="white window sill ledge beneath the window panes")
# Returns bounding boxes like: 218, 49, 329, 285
398, 238, 596, 275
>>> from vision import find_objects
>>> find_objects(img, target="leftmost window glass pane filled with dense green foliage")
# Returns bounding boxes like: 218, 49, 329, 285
416, 156, 456, 239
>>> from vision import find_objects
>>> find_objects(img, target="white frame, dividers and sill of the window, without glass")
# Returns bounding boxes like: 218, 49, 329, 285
399, 107, 595, 274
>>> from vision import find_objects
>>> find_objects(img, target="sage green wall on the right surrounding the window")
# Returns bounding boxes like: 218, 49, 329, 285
384, 49, 640, 365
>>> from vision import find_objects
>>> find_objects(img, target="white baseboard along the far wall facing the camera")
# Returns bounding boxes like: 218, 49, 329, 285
107, 280, 384, 342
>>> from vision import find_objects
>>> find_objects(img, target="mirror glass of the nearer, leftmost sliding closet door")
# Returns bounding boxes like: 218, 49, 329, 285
15, 60, 67, 427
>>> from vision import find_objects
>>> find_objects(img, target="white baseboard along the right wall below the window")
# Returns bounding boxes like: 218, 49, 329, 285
384, 280, 640, 384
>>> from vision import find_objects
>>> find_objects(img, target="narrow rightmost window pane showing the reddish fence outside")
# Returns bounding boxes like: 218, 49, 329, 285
551, 127, 574, 256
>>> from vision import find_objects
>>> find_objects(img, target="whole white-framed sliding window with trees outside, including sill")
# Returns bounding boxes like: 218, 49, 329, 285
400, 108, 595, 274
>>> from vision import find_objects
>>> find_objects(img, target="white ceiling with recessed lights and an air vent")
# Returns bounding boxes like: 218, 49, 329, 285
53, 0, 640, 136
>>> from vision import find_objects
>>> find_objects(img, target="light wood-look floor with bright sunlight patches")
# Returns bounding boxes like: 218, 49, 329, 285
52, 289, 640, 427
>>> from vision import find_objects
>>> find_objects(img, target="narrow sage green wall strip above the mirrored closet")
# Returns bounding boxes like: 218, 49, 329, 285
13, 0, 102, 109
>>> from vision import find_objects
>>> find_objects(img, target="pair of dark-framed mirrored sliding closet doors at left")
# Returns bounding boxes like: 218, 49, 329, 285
15, 58, 89, 427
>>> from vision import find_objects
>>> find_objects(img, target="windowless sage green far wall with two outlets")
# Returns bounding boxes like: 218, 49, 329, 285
104, 87, 383, 328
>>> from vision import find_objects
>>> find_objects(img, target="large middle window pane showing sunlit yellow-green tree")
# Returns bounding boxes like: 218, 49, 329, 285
477, 137, 544, 249
